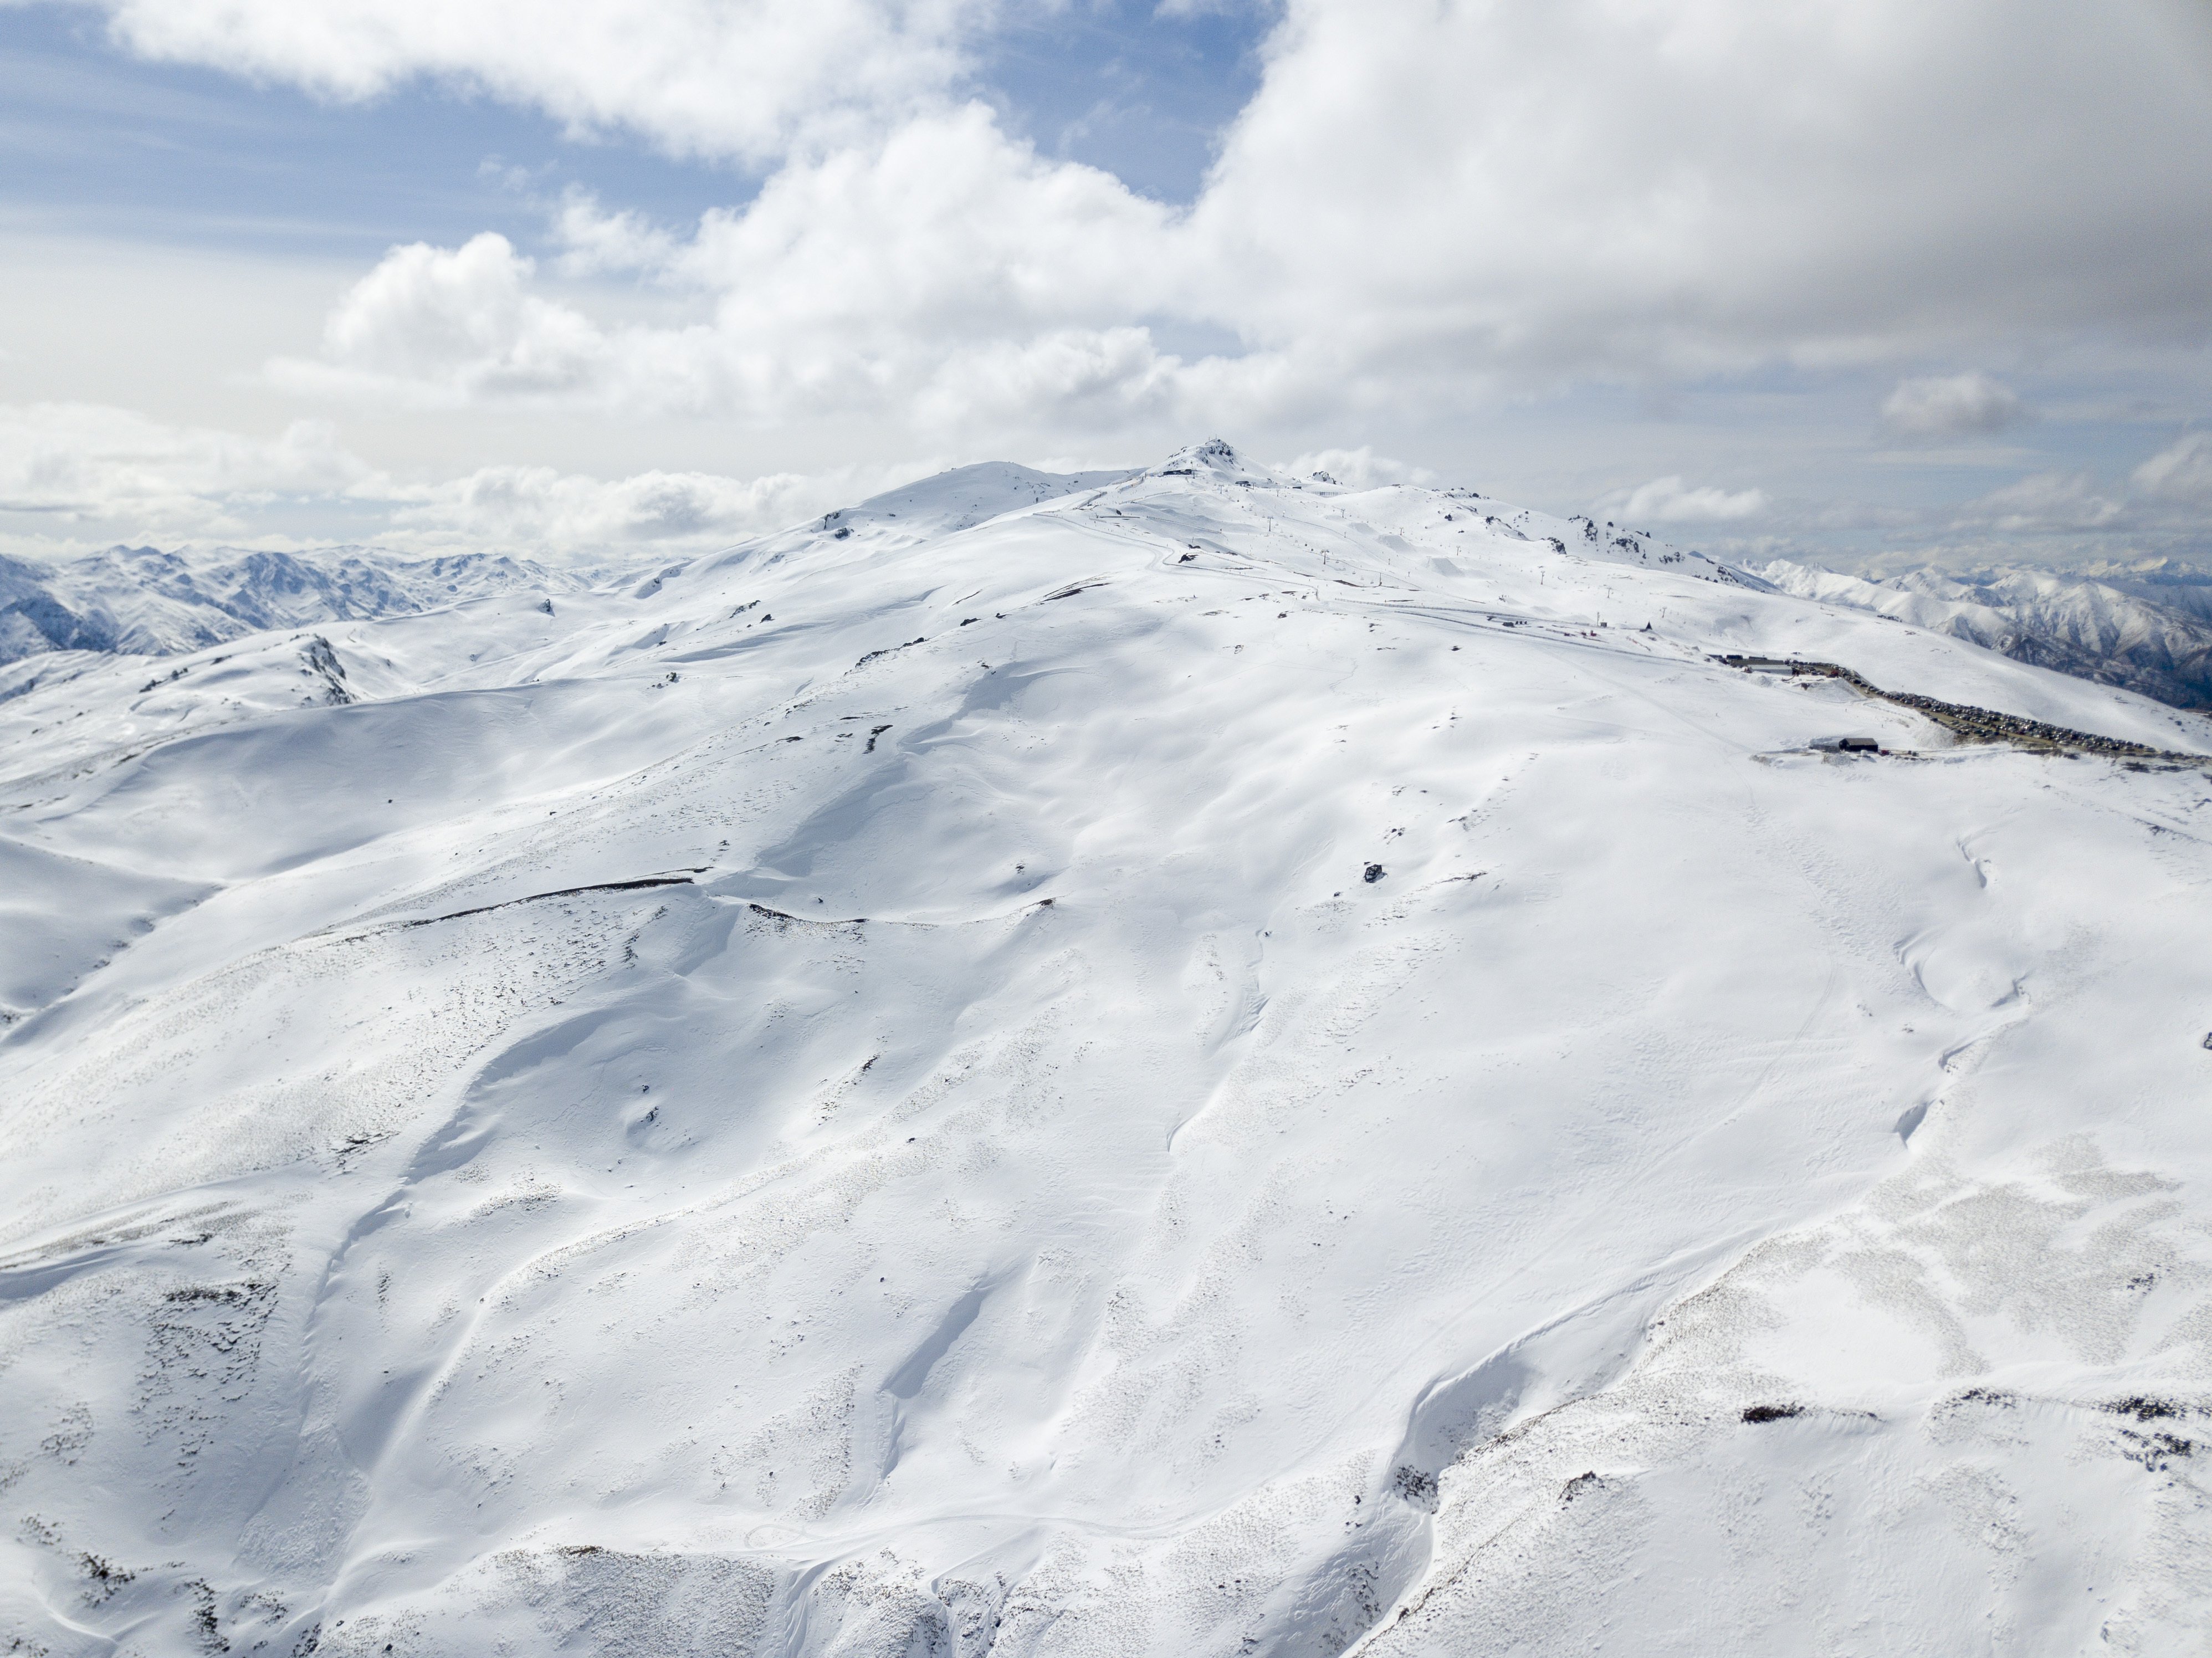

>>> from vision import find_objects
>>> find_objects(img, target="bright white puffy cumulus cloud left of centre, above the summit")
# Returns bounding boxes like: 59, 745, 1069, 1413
270, 104, 1235, 434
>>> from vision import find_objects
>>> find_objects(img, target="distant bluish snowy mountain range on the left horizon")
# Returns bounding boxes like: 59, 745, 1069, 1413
0, 547, 584, 664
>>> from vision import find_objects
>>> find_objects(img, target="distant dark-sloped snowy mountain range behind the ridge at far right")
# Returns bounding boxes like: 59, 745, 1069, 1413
1754, 560, 2212, 708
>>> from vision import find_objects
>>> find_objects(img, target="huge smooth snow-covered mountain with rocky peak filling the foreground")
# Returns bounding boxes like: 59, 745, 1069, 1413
0, 445, 2212, 1658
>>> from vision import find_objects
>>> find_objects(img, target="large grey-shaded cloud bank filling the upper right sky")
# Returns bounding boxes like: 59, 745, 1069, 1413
1192, 0, 2212, 381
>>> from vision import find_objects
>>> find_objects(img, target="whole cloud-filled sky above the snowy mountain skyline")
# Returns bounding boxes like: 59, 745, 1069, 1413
0, 0, 2212, 562
